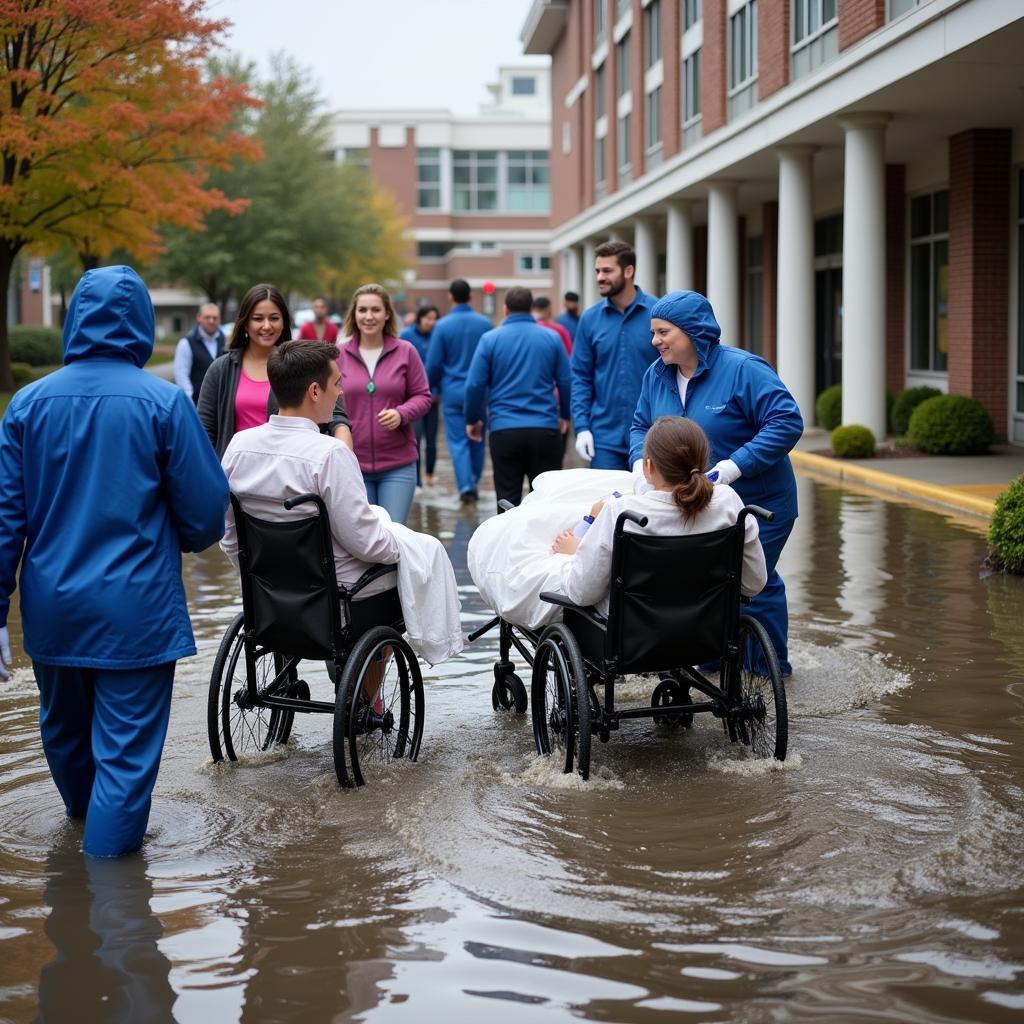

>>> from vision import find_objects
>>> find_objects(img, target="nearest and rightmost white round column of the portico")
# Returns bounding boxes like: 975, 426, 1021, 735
841, 114, 889, 438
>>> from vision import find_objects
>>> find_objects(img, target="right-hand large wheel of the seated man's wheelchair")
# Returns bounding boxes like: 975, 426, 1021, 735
334, 626, 423, 786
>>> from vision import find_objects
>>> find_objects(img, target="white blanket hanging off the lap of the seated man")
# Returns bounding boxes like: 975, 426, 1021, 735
371, 505, 465, 665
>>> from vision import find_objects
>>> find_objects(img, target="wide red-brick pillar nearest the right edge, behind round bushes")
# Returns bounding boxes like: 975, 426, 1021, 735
949, 128, 1011, 436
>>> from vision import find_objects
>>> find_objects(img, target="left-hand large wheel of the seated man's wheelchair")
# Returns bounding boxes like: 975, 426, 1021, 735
207, 613, 293, 761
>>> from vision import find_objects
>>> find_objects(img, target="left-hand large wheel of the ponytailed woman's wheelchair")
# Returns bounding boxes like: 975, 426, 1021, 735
530, 623, 590, 779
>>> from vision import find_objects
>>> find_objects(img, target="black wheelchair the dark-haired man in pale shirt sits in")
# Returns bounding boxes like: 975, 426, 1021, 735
207, 494, 424, 788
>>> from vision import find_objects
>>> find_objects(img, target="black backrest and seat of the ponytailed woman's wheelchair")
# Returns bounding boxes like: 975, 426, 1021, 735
563, 515, 743, 675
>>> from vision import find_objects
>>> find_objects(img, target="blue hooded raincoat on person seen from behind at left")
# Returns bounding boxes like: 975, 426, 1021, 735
0, 266, 227, 670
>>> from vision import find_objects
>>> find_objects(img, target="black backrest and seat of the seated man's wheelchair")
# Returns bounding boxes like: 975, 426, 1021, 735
230, 494, 404, 660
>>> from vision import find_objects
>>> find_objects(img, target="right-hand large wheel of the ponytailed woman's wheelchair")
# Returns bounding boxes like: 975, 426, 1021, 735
738, 615, 790, 761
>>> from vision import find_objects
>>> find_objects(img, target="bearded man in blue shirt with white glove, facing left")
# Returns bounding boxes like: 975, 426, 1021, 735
572, 242, 657, 469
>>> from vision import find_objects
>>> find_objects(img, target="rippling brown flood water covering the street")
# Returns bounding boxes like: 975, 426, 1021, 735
0, 466, 1024, 1024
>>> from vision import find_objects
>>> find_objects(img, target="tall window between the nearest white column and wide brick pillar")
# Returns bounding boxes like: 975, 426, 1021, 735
910, 190, 949, 373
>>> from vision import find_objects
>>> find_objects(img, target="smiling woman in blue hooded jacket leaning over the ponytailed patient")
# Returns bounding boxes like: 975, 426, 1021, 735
630, 292, 804, 675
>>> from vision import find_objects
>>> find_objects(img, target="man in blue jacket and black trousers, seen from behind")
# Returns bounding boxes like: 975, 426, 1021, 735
465, 288, 571, 505
